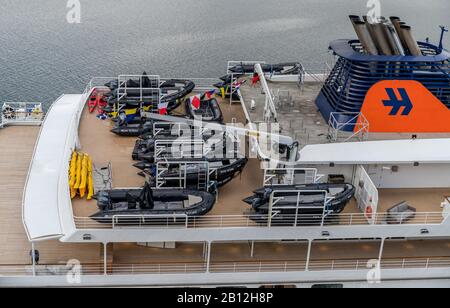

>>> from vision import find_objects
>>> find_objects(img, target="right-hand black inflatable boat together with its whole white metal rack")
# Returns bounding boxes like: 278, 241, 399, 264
243, 184, 355, 223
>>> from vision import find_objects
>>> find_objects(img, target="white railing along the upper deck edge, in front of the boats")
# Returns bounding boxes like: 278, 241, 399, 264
74, 212, 447, 230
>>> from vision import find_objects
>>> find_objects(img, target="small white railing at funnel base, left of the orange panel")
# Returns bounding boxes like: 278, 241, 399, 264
328, 112, 370, 142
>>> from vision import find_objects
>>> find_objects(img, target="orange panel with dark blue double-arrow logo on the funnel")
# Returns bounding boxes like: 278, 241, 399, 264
358, 80, 450, 133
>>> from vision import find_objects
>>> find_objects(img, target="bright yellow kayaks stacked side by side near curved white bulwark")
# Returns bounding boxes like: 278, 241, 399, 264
69, 151, 94, 200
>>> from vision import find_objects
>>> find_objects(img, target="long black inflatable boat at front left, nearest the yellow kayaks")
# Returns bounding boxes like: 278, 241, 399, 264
91, 184, 216, 225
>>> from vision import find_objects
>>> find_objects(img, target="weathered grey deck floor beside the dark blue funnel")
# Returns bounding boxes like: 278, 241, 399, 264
240, 76, 450, 146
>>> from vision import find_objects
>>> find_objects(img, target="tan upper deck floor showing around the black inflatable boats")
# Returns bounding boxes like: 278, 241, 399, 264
69, 91, 450, 228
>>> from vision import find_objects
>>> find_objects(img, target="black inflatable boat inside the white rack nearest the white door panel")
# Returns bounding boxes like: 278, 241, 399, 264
243, 184, 355, 215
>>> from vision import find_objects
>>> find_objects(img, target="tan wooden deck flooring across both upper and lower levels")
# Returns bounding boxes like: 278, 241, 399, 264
0, 91, 450, 273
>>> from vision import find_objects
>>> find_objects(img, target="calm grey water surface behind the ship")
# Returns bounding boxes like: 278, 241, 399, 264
0, 0, 450, 103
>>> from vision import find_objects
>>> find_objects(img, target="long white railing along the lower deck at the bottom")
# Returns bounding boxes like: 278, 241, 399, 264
0, 257, 450, 277
